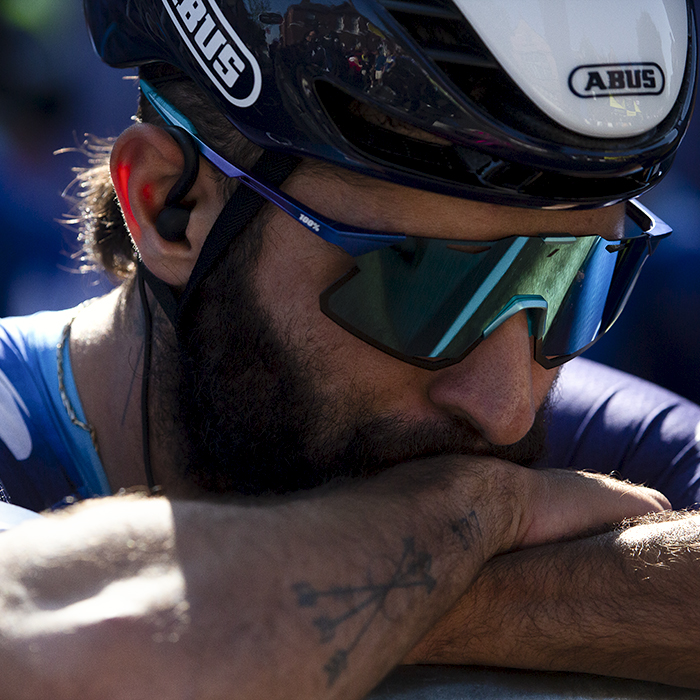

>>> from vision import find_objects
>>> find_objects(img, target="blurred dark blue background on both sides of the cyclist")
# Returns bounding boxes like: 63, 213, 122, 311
0, 0, 700, 402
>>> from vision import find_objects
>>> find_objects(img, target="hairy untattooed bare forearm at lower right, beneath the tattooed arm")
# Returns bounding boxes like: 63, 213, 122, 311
407, 506, 700, 688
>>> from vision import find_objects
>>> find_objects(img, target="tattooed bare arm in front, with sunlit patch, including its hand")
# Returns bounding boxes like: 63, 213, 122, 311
0, 458, 664, 700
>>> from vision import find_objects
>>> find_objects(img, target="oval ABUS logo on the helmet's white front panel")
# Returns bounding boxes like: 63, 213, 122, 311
569, 63, 666, 98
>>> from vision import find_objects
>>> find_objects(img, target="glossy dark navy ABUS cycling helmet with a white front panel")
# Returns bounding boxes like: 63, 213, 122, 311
84, 0, 697, 208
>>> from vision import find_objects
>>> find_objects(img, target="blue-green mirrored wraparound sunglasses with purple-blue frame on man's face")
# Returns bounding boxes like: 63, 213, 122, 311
141, 81, 671, 369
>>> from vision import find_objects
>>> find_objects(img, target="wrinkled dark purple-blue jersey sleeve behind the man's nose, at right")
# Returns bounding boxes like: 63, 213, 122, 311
542, 358, 700, 509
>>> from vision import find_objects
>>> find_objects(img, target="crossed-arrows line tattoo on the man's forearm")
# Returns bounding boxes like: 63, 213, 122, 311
292, 537, 436, 687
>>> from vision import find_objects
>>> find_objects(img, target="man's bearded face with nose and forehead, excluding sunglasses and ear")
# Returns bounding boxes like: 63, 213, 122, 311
168, 161, 623, 493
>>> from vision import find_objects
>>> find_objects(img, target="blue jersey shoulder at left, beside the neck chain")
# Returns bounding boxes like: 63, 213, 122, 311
0, 309, 110, 511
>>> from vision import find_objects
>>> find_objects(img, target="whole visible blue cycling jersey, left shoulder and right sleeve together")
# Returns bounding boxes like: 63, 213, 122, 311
0, 309, 700, 511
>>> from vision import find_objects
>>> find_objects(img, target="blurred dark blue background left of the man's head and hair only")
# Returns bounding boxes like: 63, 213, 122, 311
0, 0, 131, 316
